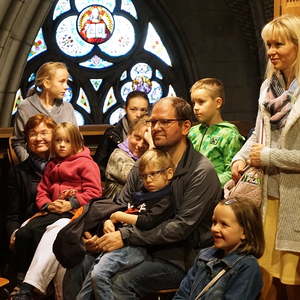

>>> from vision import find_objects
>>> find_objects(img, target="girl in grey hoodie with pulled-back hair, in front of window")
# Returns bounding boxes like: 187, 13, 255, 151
12, 62, 76, 161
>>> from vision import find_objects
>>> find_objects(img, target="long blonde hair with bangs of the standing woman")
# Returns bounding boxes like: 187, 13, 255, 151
261, 15, 300, 84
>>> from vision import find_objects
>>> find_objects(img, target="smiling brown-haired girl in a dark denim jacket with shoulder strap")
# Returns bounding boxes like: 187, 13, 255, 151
173, 198, 265, 300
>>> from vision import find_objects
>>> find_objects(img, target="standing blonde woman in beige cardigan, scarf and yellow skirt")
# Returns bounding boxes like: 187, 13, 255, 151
232, 15, 300, 299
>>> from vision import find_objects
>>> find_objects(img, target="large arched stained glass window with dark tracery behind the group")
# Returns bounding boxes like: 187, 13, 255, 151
13, 0, 185, 125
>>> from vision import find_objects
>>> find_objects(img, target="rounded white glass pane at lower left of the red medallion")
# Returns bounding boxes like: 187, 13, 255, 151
56, 16, 94, 56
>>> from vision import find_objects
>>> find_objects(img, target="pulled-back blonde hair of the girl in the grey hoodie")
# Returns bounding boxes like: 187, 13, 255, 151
27, 61, 68, 97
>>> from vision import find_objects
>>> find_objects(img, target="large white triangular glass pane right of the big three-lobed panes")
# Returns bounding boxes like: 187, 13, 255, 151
144, 23, 172, 66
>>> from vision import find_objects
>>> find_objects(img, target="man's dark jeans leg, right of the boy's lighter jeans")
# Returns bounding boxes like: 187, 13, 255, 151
112, 256, 185, 300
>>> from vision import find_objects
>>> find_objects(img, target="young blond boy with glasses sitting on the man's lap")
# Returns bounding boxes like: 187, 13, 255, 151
76, 149, 175, 300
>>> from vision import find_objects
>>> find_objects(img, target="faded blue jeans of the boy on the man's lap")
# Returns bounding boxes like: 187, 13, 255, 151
76, 247, 147, 300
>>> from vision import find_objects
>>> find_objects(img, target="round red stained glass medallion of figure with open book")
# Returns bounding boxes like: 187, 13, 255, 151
77, 5, 114, 44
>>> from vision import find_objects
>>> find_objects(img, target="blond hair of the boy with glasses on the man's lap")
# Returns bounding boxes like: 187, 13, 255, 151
139, 149, 174, 174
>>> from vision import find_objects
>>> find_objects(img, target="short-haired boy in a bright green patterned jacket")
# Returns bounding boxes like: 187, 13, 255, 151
188, 78, 244, 186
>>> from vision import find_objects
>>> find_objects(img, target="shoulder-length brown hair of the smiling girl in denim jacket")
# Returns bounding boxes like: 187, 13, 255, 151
219, 198, 265, 258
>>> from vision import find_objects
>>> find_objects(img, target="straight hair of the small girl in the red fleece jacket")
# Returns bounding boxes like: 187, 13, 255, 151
52, 122, 84, 154
